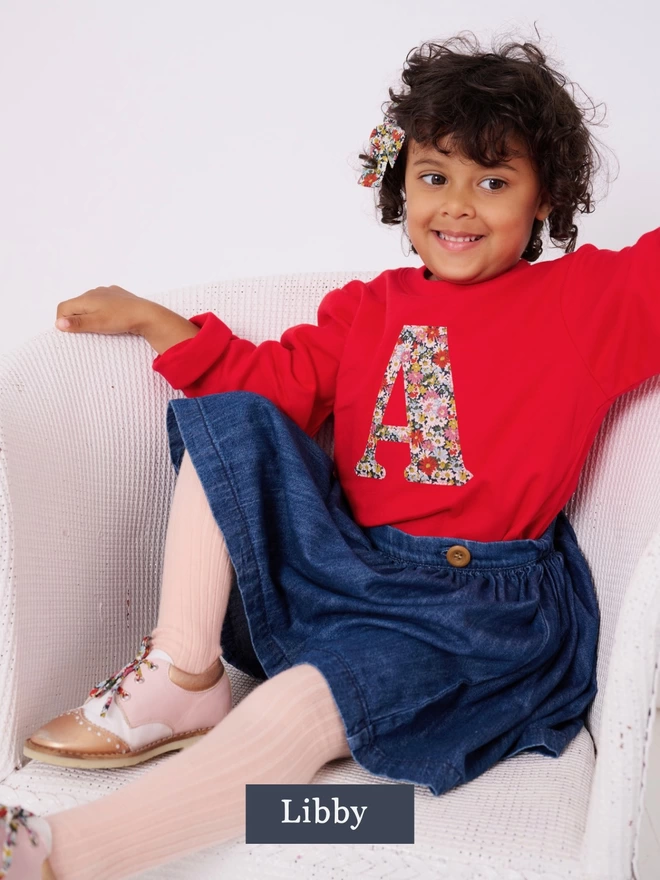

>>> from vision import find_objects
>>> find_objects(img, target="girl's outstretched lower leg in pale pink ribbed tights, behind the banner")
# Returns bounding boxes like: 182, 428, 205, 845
47, 663, 351, 880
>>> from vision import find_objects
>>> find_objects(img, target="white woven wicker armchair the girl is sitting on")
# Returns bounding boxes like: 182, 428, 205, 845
0, 272, 660, 880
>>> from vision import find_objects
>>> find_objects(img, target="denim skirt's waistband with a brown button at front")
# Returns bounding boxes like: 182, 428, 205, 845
363, 510, 566, 571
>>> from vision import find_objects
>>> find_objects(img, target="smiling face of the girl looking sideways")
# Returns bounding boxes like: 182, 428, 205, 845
405, 138, 552, 284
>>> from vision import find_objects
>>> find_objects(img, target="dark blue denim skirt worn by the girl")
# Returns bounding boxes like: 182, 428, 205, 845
166, 391, 600, 795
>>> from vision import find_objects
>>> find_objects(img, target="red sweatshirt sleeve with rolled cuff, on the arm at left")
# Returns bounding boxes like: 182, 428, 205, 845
152, 280, 365, 436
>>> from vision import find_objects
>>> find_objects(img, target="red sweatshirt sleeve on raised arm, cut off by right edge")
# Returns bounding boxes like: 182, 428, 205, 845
560, 228, 660, 399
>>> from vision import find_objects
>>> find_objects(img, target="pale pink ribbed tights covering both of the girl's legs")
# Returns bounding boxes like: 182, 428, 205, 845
47, 453, 350, 880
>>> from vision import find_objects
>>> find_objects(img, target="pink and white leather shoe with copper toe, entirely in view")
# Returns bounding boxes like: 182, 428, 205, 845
23, 635, 232, 768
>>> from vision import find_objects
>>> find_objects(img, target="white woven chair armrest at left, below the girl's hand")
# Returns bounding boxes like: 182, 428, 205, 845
0, 322, 181, 780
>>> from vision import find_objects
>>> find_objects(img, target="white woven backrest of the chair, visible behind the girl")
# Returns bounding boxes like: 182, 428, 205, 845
152, 271, 660, 745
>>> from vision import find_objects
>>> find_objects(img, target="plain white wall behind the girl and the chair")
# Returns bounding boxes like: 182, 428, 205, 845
0, 0, 660, 353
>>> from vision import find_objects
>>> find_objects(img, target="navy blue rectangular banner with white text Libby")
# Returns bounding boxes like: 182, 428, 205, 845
245, 783, 415, 843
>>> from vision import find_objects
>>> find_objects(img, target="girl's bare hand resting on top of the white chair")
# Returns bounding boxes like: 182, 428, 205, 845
55, 284, 153, 333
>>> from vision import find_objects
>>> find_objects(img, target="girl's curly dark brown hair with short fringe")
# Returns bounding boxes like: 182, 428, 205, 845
359, 25, 612, 263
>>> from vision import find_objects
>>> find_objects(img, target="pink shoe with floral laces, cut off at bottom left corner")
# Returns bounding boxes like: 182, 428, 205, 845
0, 804, 53, 880
